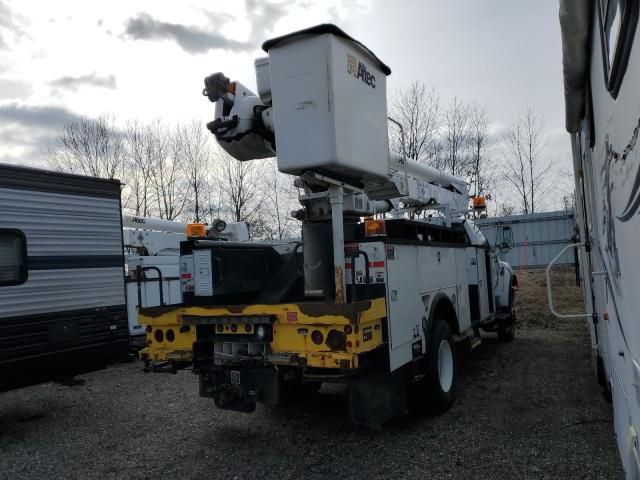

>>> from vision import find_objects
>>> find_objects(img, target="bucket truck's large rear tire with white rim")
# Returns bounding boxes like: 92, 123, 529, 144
425, 319, 457, 412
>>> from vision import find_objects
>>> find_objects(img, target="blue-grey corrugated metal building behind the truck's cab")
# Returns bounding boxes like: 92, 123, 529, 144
476, 210, 574, 268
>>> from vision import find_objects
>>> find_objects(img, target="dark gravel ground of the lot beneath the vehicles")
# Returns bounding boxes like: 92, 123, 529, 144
0, 271, 622, 479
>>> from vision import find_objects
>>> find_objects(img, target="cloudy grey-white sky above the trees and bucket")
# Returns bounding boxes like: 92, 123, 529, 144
0, 0, 569, 203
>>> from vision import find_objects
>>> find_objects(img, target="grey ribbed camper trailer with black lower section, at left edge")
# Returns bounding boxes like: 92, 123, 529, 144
0, 165, 129, 390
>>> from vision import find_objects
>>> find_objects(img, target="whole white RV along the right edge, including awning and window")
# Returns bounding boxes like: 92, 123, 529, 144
549, 0, 640, 479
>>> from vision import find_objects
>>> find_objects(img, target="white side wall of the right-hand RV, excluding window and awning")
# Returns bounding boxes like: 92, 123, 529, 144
574, 2, 640, 478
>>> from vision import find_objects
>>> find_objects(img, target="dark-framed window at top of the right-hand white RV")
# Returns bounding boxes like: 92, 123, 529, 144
598, 0, 640, 98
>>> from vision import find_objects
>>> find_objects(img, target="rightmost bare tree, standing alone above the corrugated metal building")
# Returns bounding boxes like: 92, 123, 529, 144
503, 108, 552, 214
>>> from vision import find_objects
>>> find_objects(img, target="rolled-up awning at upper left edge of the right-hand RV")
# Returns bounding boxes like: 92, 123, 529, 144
560, 0, 591, 133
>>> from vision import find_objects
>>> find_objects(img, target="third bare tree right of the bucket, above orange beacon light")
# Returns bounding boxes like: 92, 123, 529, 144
469, 104, 493, 195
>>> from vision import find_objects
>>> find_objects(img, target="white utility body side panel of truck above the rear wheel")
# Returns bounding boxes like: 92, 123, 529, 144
346, 241, 492, 371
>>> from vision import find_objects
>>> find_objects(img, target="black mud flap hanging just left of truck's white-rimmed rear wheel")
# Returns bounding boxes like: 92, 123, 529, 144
349, 370, 409, 429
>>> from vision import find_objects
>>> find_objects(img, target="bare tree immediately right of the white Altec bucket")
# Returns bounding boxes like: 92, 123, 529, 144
390, 81, 440, 161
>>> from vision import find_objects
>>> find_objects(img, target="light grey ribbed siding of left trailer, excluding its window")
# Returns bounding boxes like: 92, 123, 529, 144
0, 188, 125, 318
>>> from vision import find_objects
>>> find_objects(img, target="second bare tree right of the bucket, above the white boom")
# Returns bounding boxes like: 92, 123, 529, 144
438, 97, 470, 176
